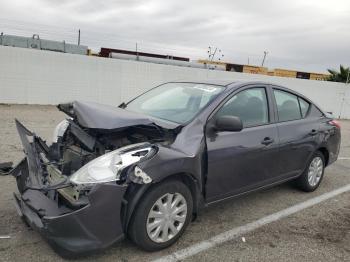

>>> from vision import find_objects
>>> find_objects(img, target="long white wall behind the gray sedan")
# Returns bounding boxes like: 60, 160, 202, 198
0, 46, 350, 119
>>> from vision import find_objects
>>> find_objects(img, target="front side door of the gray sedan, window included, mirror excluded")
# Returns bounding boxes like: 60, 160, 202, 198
206, 86, 279, 202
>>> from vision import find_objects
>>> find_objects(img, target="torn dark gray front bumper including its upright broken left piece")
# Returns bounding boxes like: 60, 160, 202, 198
12, 122, 126, 257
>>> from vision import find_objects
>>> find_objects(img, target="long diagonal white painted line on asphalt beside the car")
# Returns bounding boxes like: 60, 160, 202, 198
154, 184, 350, 262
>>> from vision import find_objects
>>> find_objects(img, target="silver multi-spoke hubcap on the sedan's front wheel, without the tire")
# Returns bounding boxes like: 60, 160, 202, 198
146, 193, 187, 243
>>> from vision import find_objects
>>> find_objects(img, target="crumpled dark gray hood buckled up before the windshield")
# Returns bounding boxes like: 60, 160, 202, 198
58, 101, 153, 129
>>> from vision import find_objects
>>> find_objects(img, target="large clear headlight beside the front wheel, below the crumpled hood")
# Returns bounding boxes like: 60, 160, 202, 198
70, 146, 155, 185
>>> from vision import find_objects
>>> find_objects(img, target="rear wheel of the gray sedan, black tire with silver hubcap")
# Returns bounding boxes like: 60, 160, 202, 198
296, 151, 325, 192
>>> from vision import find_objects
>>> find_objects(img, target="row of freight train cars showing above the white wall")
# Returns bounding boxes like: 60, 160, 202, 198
0, 33, 329, 80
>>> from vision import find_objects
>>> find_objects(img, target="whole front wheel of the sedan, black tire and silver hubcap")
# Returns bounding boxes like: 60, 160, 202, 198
128, 180, 193, 251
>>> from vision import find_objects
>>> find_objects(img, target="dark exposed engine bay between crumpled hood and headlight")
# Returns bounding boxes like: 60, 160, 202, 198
49, 120, 167, 180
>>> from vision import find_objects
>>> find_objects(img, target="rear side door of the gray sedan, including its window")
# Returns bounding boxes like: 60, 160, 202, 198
273, 87, 320, 177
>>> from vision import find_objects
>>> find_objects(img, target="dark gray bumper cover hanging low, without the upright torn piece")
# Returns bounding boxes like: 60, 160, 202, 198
15, 184, 125, 256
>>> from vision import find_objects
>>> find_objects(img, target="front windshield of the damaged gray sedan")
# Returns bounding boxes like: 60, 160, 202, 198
126, 83, 224, 124
